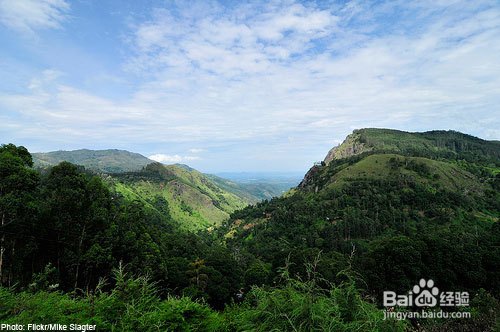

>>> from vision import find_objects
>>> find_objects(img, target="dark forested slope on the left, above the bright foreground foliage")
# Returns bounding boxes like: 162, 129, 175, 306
0, 144, 239, 308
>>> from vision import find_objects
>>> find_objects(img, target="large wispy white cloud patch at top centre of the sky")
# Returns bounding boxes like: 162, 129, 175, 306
128, 3, 338, 77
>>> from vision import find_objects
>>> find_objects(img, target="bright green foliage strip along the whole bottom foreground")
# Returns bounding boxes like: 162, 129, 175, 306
0, 264, 410, 331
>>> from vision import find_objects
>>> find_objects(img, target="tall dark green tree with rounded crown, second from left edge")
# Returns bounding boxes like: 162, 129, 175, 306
40, 162, 111, 290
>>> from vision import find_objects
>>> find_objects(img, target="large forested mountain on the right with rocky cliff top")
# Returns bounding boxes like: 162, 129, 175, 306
220, 129, 500, 328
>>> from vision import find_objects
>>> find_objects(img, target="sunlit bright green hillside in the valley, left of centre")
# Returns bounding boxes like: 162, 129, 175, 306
112, 163, 248, 230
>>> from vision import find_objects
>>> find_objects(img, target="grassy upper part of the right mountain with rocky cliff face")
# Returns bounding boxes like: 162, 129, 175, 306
299, 128, 500, 194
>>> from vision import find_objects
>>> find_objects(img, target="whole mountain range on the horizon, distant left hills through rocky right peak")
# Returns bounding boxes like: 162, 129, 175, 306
32, 128, 500, 229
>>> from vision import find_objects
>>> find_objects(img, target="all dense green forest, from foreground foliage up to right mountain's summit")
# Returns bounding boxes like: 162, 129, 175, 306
0, 130, 500, 331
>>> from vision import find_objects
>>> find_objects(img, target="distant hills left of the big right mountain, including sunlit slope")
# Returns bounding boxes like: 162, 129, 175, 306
32, 149, 300, 230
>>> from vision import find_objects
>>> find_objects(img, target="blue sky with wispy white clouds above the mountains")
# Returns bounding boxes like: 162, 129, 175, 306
0, 0, 500, 173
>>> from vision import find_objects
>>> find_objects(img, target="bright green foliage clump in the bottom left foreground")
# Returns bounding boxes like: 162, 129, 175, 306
0, 268, 223, 331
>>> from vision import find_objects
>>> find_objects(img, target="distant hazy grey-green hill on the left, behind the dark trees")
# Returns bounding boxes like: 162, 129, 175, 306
32, 149, 153, 173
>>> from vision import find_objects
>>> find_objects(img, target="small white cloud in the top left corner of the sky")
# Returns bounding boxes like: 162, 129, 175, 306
0, 0, 70, 34
